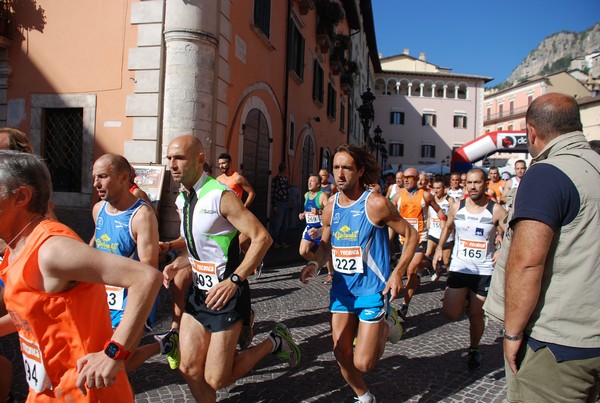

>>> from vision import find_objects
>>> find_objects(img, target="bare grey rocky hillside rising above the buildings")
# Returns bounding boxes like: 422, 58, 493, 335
499, 23, 600, 87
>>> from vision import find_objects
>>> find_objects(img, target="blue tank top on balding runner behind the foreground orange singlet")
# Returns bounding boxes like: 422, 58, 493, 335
95, 199, 145, 328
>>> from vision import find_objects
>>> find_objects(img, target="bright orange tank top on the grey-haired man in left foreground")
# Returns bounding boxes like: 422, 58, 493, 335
0, 220, 133, 402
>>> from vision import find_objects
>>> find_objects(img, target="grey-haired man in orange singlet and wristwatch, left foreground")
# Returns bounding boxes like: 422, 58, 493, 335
0, 151, 161, 402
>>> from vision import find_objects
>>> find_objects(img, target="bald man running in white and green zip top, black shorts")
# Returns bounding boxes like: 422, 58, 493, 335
163, 135, 301, 401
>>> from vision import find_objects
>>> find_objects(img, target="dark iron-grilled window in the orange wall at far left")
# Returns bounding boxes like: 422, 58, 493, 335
43, 108, 83, 193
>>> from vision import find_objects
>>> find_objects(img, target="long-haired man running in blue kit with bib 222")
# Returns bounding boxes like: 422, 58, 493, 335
300, 144, 417, 403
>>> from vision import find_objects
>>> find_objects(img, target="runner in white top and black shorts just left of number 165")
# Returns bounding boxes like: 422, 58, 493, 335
425, 174, 454, 281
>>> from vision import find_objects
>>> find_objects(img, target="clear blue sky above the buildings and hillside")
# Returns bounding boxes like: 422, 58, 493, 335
372, 0, 600, 86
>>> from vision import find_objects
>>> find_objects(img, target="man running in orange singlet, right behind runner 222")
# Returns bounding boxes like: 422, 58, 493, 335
393, 168, 447, 318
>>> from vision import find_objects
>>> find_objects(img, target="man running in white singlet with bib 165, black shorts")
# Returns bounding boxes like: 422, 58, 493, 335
433, 168, 506, 370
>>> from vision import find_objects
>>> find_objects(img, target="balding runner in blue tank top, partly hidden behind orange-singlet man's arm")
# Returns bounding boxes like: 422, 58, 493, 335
91, 154, 179, 372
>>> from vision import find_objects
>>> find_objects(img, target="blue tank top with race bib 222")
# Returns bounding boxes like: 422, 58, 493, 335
331, 190, 391, 296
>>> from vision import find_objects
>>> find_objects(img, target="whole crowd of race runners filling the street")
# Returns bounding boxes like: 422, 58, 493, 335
0, 93, 597, 403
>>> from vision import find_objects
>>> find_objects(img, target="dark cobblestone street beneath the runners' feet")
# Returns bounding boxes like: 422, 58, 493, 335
0, 264, 506, 402
